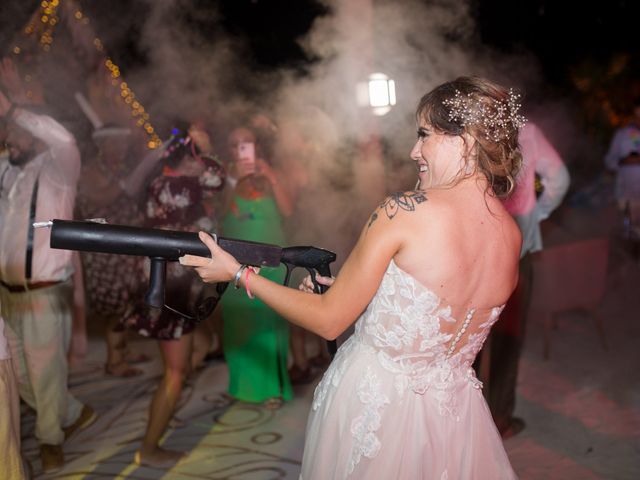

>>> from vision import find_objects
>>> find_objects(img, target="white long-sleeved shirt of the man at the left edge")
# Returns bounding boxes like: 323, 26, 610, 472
0, 109, 80, 285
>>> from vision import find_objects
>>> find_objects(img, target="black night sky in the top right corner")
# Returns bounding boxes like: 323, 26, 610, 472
474, 0, 640, 84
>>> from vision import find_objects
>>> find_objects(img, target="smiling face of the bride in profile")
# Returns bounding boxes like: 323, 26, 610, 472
410, 120, 464, 189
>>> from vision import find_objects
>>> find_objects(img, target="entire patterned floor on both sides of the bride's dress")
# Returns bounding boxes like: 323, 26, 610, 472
22, 204, 640, 480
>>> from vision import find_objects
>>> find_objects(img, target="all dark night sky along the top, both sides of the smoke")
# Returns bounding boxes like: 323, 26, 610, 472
0, 0, 640, 144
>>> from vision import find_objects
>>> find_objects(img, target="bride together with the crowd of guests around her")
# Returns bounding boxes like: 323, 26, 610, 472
0, 44, 588, 479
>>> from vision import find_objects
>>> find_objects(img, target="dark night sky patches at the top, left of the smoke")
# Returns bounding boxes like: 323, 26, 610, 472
0, 0, 328, 69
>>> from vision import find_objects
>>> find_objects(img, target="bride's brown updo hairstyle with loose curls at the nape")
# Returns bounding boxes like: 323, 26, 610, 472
416, 77, 522, 197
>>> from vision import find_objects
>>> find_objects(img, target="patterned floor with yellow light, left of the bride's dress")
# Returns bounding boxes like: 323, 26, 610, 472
22, 339, 313, 480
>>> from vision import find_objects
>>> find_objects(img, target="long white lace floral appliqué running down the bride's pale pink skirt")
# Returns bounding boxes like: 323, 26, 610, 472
347, 368, 389, 474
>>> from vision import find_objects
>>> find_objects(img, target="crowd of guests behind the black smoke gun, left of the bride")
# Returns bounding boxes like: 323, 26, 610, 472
0, 54, 340, 478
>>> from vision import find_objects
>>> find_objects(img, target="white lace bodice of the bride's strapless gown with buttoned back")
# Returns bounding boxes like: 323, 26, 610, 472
313, 260, 504, 414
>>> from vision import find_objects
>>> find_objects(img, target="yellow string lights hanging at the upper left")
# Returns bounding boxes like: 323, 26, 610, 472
12, 0, 162, 149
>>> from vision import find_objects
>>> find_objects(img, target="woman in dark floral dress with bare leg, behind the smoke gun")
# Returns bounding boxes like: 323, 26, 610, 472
125, 129, 224, 467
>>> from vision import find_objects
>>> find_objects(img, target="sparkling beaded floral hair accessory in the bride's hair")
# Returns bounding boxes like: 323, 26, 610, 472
442, 89, 526, 142
